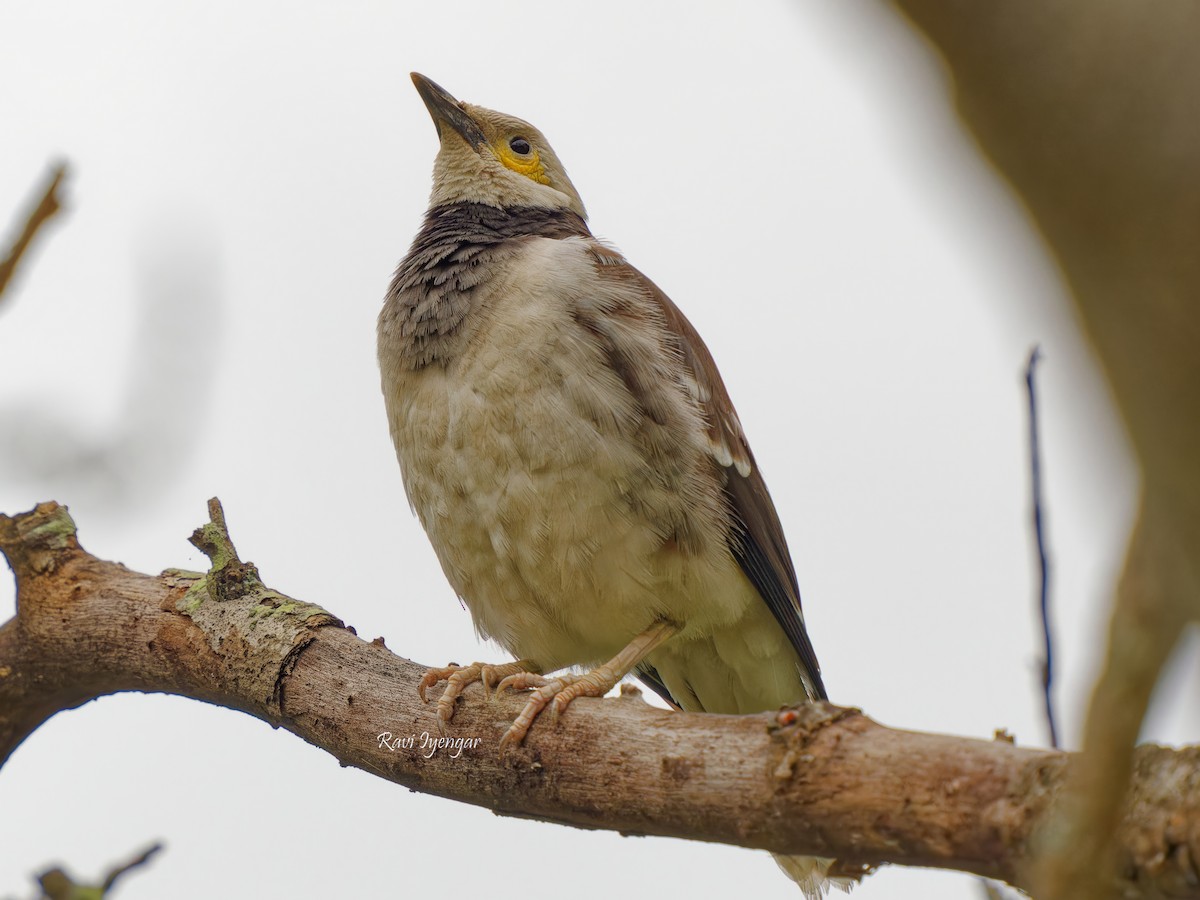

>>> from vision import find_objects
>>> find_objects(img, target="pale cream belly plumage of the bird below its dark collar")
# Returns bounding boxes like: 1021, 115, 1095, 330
385, 242, 803, 713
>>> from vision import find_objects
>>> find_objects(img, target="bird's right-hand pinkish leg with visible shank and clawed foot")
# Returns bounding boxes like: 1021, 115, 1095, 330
492, 622, 679, 754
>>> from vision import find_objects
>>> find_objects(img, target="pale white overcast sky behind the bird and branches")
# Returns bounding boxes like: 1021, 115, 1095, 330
0, 0, 1198, 900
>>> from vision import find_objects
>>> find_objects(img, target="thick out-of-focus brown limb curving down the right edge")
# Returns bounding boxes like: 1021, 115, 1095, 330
894, 0, 1200, 900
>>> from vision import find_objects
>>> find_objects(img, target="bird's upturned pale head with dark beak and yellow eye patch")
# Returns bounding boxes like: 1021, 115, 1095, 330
413, 72, 587, 220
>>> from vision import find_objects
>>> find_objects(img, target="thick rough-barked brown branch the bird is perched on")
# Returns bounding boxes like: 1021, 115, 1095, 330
0, 503, 1200, 898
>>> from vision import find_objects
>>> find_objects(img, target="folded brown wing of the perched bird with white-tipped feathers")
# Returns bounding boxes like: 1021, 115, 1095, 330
594, 245, 828, 700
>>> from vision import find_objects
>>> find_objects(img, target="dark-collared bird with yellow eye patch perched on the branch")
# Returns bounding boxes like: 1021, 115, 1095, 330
378, 72, 842, 896
